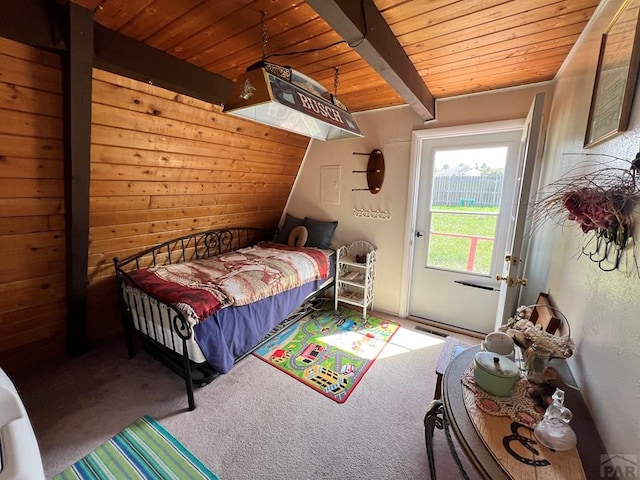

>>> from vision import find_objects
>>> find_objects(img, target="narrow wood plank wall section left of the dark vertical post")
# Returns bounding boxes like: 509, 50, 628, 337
0, 38, 66, 373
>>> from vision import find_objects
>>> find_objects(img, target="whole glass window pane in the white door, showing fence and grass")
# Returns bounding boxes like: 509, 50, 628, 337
427, 146, 508, 275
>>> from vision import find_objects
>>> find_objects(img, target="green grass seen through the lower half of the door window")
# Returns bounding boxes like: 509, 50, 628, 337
427, 206, 499, 275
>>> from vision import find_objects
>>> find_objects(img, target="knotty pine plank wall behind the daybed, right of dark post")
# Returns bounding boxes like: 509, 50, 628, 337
88, 69, 308, 339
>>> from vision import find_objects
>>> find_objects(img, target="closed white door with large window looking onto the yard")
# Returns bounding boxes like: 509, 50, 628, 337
409, 120, 523, 333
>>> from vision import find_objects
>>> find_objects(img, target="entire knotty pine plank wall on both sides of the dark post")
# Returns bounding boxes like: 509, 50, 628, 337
0, 38, 308, 373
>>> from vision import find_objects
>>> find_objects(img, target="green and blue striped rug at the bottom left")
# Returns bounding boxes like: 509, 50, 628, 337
54, 415, 218, 480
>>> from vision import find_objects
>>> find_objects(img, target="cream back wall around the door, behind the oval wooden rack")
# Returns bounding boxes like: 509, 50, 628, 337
287, 83, 552, 315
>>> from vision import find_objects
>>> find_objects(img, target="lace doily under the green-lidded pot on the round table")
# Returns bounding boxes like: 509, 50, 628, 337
462, 365, 544, 428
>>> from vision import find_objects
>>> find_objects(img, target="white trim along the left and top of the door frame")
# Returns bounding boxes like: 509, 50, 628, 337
398, 118, 525, 318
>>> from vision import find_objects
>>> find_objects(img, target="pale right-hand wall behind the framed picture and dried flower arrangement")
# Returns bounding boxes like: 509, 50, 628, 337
527, 0, 640, 455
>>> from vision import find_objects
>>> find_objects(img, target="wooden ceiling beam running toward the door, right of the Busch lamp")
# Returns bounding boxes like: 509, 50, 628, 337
307, 0, 436, 121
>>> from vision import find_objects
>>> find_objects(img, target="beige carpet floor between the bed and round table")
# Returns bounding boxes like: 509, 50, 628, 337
16, 319, 480, 480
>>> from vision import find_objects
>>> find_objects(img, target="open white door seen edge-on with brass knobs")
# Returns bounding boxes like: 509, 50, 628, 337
495, 93, 544, 327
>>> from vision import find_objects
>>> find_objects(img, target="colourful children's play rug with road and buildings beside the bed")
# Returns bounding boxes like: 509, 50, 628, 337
253, 308, 400, 403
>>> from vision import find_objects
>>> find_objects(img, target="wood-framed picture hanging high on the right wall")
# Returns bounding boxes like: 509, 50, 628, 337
584, 0, 640, 147
